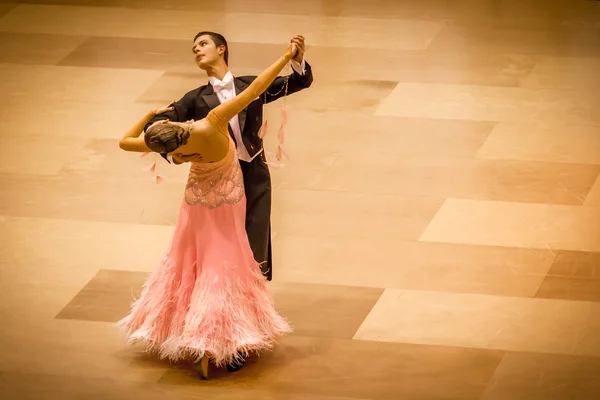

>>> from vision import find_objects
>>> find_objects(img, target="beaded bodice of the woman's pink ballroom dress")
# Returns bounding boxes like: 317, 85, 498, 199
185, 139, 244, 208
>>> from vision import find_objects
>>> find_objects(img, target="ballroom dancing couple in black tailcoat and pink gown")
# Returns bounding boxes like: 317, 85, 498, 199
119, 32, 313, 378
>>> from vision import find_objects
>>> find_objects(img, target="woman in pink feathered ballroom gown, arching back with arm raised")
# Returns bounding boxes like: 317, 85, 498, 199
118, 44, 296, 378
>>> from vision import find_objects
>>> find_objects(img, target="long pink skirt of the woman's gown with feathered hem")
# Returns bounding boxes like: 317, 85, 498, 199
118, 197, 291, 365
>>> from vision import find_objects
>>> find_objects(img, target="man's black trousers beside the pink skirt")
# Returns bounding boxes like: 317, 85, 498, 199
240, 152, 273, 281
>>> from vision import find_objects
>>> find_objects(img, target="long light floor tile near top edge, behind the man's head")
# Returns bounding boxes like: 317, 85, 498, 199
0, 5, 443, 50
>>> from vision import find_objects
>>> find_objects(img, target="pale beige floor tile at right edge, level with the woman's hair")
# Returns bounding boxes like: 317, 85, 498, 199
477, 123, 600, 165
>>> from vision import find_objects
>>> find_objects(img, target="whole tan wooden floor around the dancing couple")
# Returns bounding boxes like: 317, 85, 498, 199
0, 0, 600, 400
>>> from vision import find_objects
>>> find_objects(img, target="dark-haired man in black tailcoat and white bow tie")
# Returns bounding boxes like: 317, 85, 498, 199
145, 32, 313, 281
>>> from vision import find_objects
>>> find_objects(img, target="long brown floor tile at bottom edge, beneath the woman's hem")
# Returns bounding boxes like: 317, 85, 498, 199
160, 336, 502, 400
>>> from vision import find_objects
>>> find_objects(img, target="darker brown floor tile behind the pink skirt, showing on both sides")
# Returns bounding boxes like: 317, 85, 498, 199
56, 269, 383, 339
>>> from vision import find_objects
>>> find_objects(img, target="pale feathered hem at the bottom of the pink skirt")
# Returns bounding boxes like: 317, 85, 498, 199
115, 256, 292, 366
